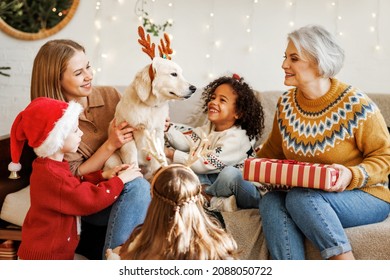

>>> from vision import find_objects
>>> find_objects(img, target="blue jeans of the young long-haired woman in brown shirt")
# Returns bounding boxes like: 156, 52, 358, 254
83, 178, 151, 259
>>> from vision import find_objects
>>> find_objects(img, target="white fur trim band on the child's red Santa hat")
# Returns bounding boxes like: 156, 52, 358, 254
34, 101, 83, 157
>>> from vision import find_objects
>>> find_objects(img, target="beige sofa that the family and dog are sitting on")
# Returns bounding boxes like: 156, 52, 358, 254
0, 87, 390, 260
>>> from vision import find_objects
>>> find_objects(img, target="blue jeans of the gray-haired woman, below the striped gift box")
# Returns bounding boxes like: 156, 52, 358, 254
259, 188, 390, 260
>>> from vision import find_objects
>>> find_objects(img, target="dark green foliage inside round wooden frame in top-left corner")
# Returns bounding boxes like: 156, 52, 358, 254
0, 0, 73, 33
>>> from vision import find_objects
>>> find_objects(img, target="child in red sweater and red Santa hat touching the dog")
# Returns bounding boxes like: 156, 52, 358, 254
8, 97, 142, 260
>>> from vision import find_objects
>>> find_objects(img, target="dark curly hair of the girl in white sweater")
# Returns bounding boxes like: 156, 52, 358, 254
201, 74, 264, 140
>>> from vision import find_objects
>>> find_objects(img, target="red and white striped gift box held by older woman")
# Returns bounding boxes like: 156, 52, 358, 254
243, 158, 338, 189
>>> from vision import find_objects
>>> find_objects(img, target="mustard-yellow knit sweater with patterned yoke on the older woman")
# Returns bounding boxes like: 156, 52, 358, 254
257, 79, 390, 202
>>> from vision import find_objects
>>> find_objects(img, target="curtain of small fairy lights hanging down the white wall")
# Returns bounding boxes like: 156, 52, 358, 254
95, 0, 385, 79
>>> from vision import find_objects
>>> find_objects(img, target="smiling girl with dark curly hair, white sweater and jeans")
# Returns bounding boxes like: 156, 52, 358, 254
165, 74, 264, 211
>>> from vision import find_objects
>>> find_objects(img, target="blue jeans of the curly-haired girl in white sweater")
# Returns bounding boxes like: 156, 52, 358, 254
198, 166, 260, 209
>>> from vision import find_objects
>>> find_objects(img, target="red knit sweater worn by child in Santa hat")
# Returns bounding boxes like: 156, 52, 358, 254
18, 158, 123, 260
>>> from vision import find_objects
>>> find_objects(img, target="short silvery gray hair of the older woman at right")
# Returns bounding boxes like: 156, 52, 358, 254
287, 25, 345, 78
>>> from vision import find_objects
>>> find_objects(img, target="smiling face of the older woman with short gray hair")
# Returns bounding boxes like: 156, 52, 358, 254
282, 41, 320, 88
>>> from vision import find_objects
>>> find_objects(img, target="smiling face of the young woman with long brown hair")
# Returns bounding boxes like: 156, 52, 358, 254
61, 51, 93, 101
